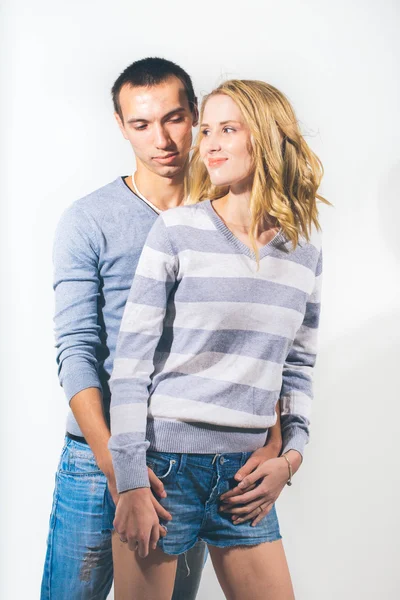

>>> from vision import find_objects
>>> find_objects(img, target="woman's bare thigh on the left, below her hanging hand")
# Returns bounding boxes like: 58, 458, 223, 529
112, 532, 178, 600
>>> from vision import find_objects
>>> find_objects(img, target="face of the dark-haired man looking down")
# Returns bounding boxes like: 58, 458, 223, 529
115, 76, 196, 177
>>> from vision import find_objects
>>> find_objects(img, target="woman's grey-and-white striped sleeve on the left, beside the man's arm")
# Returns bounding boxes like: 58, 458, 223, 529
109, 217, 177, 493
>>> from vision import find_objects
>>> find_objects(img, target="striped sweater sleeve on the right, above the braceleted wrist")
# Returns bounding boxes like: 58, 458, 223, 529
280, 252, 322, 456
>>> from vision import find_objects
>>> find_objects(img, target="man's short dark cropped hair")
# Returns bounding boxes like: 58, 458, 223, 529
111, 57, 197, 121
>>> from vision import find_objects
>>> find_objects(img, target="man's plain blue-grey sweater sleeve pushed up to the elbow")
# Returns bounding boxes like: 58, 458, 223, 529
53, 204, 101, 401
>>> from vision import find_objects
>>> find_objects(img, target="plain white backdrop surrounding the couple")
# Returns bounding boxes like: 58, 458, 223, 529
0, 0, 400, 600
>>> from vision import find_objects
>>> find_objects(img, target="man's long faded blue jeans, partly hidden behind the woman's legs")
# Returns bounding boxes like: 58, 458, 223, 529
41, 438, 207, 600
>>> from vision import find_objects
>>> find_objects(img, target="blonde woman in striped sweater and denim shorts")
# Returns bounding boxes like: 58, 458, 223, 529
110, 80, 325, 600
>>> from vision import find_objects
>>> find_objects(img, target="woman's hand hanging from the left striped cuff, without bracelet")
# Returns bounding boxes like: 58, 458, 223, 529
114, 488, 169, 558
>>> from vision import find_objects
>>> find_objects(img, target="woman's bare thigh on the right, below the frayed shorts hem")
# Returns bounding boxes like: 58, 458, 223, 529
208, 540, 294, 600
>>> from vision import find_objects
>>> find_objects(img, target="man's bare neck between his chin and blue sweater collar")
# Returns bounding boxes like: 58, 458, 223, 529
125, 168, 184, 210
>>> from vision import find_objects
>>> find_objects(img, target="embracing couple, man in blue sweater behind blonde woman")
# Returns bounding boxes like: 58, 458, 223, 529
41, 58, 325, 600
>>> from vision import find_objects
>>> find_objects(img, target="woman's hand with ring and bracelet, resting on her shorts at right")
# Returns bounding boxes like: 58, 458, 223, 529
220, 447, 302, 526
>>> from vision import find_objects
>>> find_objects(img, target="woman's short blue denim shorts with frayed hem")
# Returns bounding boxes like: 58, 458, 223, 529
147, 450, 282, 554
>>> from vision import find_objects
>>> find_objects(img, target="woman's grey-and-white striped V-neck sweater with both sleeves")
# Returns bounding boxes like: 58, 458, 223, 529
109, 201, 322, 492
